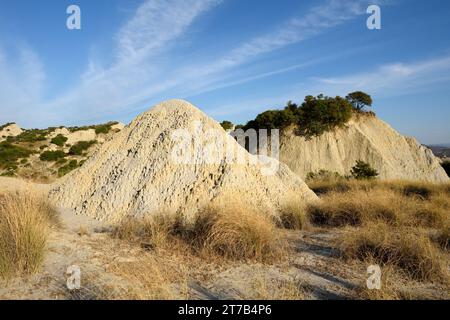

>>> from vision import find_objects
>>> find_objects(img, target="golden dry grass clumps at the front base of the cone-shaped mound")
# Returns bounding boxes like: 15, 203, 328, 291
113, 199, 284, 262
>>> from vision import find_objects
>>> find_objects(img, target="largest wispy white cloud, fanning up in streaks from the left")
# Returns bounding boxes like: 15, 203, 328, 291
0, 0, 396, 125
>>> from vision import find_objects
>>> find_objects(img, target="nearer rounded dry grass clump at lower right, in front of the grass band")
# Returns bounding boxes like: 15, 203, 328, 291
340, 223, 448, 283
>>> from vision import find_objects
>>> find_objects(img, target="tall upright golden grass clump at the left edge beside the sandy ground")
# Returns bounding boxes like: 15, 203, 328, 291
0, 189, 57, 279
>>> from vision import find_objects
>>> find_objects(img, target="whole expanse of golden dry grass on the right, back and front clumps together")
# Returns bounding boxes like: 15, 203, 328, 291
307, 181, 450, 283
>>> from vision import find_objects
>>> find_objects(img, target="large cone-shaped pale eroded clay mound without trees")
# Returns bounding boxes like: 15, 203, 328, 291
50, 100, 316, 221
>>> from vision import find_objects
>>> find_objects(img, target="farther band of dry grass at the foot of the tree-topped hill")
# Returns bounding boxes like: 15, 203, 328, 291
307, 182, 450, 229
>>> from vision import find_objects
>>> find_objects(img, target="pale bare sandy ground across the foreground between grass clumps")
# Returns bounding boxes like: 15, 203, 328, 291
0, 178, 449, 299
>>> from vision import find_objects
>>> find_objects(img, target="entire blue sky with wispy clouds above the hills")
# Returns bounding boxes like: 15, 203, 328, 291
0, 0, 450, 144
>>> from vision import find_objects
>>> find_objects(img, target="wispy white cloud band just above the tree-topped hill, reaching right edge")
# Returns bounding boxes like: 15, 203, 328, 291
209, 56, 450, 119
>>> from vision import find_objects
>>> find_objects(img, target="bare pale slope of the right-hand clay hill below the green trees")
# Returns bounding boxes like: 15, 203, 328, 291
280, 115, 448, 182
